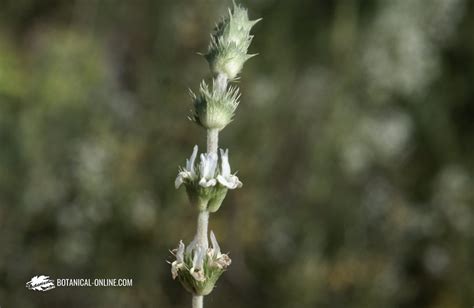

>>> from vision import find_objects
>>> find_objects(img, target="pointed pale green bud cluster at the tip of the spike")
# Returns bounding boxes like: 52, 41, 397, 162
204, 3, 261, 80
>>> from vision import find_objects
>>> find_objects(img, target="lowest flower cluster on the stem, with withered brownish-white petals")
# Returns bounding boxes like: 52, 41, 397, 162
171, 231, 231, 295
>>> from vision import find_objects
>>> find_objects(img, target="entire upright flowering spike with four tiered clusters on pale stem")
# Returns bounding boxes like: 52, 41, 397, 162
171, 2, 261, 307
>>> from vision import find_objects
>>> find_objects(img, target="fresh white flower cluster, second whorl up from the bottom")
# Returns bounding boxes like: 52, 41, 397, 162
175, 145, 242, 213
